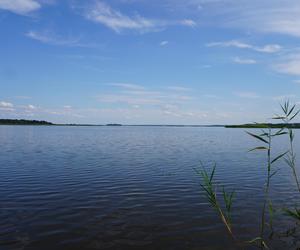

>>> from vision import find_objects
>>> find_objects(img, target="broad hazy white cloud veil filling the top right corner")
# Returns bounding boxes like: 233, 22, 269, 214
188, 0, 300, 37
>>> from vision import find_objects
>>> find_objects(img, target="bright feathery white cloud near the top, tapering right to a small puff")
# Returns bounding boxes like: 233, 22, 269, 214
85, 1, 196, 33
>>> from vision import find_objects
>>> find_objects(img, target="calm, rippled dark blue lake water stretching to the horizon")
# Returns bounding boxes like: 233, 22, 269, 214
0, 126, 300, 250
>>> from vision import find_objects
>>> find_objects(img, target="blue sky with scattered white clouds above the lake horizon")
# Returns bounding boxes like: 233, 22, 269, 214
0, 0, 300, 125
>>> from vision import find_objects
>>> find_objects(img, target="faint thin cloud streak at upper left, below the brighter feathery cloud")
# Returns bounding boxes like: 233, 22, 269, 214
25, 31, 94, 47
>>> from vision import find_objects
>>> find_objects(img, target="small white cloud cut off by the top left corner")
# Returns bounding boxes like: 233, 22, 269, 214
0, 0, 41, 15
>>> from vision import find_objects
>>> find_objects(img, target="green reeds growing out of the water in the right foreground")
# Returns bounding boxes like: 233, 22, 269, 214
196, 102, 300, 249
